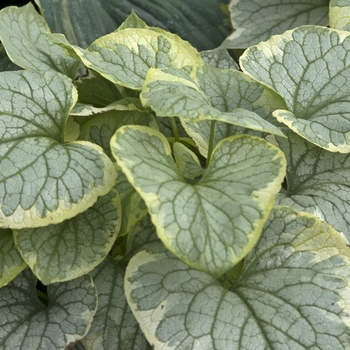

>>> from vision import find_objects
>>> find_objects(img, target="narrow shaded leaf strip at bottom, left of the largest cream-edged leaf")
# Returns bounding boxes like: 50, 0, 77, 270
82, 256, 149, 350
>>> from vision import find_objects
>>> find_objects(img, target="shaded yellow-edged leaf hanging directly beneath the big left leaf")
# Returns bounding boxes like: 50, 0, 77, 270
14, 191, 121, 285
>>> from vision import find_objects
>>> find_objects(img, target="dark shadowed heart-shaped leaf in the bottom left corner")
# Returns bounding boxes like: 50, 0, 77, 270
0, 269, 97, 350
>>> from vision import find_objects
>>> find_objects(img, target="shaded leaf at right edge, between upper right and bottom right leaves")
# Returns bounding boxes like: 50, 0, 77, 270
276, 131, 350, 241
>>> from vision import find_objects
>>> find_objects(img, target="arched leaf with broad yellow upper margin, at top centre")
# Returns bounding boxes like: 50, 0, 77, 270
50, 18, 203, 90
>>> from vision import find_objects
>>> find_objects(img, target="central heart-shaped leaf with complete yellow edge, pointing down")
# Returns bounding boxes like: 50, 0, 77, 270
111, 126, 285, 276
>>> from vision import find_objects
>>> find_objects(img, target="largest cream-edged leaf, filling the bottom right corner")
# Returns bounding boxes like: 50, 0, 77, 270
125, 207, 350, 350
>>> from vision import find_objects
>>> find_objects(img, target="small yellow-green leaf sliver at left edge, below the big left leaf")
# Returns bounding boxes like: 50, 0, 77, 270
0, 229, 27, 288
